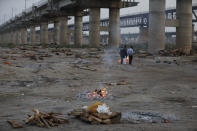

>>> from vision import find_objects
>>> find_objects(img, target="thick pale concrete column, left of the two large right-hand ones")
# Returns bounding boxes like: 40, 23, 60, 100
148, 0, 166, 54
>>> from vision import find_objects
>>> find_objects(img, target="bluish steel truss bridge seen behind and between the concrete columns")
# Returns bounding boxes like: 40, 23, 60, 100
68, 4, 197, 31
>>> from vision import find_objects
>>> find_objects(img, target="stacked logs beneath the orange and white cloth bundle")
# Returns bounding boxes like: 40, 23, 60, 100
68, 109, 121, 124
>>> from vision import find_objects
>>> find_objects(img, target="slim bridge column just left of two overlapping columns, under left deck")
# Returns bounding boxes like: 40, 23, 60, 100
40, 22, 48, 44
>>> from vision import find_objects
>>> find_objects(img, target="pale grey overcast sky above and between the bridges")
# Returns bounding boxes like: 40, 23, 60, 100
0, 0, 197, 32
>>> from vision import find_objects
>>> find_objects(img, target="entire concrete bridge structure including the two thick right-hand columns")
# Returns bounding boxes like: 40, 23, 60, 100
0, 0, 196, 53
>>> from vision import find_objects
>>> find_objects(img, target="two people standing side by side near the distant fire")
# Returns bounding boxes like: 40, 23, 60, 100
120, 45, 133, 64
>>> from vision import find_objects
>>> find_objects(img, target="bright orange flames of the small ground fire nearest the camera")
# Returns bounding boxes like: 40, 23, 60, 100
87, 88, 108, 98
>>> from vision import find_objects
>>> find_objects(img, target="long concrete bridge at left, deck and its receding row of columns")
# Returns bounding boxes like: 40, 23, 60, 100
0, 0, 138, 46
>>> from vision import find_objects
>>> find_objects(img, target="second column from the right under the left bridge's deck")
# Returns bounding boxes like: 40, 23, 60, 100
89, 8, 100, 47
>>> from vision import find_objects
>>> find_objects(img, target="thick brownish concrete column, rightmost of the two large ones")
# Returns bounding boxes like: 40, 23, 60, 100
176, 0, 192, 54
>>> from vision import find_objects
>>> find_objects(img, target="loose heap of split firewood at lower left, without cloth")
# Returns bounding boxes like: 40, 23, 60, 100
25, 109, 68, 128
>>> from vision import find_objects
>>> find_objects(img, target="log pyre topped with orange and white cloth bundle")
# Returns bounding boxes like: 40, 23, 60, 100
68, 102, 121, 124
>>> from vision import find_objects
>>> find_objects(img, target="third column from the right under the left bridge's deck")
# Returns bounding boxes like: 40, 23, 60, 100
74, 12, 83, 46
